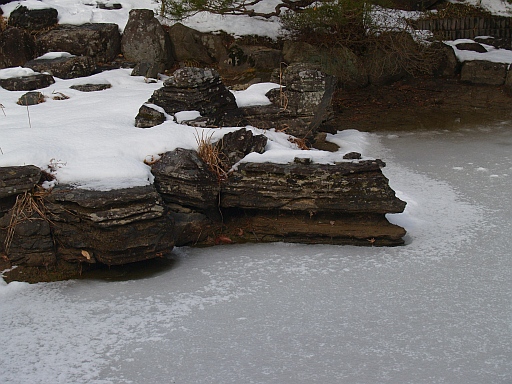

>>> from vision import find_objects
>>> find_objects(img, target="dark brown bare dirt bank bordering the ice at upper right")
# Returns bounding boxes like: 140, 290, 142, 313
327, 78, 512, 132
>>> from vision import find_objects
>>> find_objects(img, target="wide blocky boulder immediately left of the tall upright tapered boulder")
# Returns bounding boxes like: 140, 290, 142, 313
36, 23, 121, 63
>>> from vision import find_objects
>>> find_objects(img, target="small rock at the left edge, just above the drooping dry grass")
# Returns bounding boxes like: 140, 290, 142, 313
0, 165, 41, 199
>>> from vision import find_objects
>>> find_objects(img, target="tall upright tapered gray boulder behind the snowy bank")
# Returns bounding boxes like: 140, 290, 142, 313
121, 9, 174, 69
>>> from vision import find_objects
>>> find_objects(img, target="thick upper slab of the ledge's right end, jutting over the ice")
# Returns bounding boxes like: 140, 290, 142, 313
221, 160, 405, 214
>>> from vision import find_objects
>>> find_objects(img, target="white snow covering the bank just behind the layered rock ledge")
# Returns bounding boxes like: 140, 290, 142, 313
0, 68, 364, 190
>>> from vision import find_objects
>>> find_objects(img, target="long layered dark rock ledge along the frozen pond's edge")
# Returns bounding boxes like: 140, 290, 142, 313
0, 134, 405, 280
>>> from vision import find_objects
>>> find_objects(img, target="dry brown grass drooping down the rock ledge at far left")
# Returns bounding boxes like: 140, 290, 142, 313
4, 187, 51, 254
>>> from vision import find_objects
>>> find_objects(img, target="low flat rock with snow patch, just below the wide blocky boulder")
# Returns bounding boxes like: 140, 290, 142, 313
24, 56, 96, 79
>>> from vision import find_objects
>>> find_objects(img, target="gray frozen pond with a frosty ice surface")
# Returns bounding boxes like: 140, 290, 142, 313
0, 123, 512, 384
